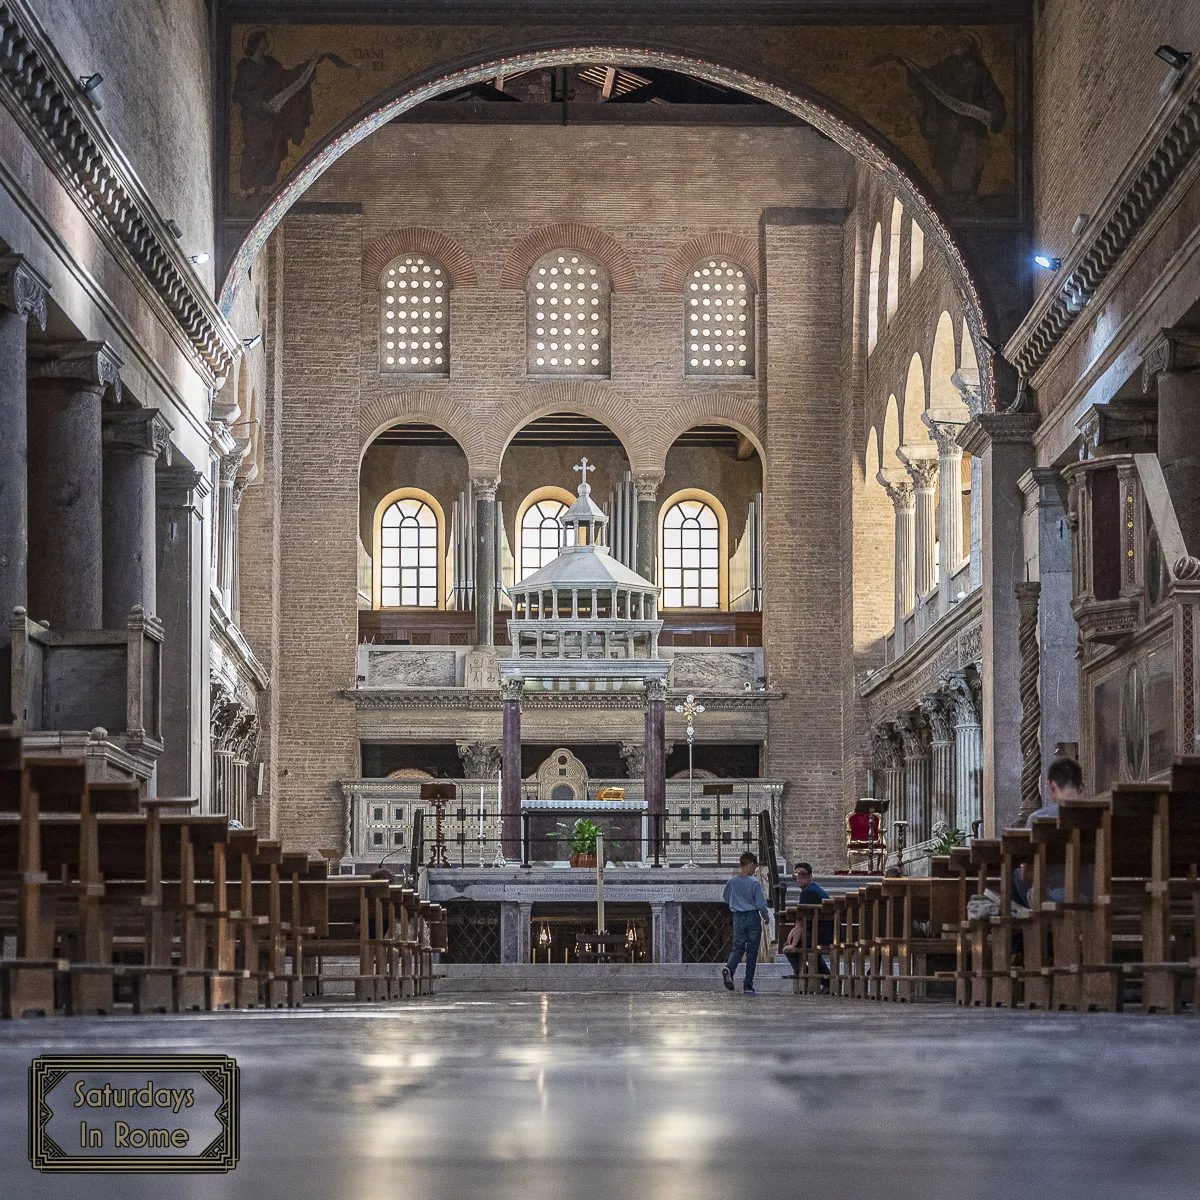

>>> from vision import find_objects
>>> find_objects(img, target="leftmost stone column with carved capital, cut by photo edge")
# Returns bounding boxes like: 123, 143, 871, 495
0, 254, 49, 725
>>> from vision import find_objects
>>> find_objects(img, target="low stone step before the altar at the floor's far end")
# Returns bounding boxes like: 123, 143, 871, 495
434, 962, 792, 996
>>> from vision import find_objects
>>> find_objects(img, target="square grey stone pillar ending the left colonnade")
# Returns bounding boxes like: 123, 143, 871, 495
155, 454, 210, 798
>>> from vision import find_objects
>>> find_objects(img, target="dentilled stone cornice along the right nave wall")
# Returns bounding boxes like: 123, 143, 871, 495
1004, 66, 1200, 385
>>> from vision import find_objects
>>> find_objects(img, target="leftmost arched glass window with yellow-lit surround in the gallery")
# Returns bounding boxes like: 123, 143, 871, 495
374, 487, 445, 608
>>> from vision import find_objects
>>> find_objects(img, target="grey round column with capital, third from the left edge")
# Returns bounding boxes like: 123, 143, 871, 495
102, 408, 170, 629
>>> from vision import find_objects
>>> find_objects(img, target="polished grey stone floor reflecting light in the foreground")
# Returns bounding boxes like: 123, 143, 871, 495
0, 990, 1200, 1200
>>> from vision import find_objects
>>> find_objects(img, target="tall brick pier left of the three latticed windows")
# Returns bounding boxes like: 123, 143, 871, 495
274, 216, 361, 847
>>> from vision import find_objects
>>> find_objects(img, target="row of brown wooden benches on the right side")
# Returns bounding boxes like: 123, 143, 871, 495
778, 758, 1200, 1013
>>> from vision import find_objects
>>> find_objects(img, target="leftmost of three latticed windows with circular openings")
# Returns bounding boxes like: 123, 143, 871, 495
379, 254, 450, 374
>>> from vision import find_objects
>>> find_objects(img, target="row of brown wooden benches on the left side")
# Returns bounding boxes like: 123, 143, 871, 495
0, 731, 445, 1016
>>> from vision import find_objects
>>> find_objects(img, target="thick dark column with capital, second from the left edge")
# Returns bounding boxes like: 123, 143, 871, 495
29, 342, 124, 629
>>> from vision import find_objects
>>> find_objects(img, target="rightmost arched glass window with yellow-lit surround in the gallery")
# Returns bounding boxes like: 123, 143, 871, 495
661, 490, 728, 608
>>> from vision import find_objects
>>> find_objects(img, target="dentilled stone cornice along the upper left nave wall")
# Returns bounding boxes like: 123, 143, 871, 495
0, 0, 241, 385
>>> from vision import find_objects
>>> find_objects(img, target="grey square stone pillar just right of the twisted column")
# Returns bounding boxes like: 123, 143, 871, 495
1020, 467, 1079, 762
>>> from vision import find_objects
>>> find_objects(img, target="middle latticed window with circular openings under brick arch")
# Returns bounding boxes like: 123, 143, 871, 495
526, 250, 610, 376
